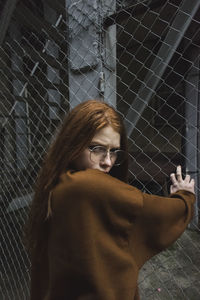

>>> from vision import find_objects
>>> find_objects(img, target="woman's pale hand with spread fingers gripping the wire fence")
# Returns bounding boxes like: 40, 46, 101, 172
170, 166, 195, 194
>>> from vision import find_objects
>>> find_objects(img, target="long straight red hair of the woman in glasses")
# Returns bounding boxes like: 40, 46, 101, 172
26, 100, 128, 254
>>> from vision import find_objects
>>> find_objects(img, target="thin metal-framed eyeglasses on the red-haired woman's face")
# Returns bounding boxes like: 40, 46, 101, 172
88, 145, 126, 166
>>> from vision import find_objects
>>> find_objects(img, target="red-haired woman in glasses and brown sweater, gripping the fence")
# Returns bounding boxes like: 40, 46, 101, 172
27, 100, 195, 300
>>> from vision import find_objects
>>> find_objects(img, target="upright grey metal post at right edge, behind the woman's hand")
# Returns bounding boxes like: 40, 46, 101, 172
184, 47, 200, 228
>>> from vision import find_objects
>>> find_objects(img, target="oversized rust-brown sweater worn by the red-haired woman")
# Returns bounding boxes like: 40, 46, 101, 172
31, 169, 195, 300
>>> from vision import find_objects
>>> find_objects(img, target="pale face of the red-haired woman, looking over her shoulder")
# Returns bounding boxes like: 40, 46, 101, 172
73, 126, 120, 173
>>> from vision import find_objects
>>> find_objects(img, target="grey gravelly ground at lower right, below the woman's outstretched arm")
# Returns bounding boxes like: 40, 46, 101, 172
139, 229, 200, 300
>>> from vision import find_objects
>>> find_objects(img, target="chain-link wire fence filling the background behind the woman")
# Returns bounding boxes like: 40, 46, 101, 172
0, 0, 200, 300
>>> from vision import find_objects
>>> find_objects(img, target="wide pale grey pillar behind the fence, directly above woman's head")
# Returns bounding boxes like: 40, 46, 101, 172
66, 0, 116, 108
